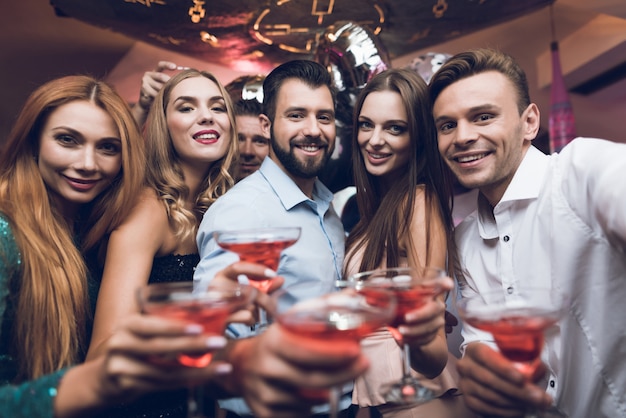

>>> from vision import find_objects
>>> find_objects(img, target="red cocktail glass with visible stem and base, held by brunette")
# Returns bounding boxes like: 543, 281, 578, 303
348, 267, 446, 405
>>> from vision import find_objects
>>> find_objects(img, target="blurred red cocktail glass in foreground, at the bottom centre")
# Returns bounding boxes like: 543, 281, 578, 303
272, 288, 396, 418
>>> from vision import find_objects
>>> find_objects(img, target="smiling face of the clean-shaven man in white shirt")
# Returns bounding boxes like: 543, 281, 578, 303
433, 71, 539, 206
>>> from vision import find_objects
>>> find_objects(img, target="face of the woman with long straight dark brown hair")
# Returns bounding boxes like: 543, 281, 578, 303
357, 90, 411, 181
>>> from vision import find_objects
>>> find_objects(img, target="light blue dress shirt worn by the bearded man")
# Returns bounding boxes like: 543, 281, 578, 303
194, 157, 349, 413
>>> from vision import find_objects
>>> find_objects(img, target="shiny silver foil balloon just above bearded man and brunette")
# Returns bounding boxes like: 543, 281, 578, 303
315, 21, 391, 94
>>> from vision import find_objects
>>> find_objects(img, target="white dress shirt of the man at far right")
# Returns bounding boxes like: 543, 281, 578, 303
455, 138, 626, 418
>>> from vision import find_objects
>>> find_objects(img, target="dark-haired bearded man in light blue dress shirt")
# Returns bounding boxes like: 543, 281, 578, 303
194, 60, 349, 416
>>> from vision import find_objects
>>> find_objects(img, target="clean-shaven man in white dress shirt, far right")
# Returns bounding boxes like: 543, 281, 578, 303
430, 50, 626, 418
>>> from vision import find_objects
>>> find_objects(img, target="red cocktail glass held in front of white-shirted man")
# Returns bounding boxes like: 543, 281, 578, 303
457, 286, 567, 418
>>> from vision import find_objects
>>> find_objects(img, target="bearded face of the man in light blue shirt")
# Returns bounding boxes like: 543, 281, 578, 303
263, 78, 335, 183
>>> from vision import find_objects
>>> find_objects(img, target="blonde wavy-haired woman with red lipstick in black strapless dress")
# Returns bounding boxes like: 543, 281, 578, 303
88, 69, 238, 416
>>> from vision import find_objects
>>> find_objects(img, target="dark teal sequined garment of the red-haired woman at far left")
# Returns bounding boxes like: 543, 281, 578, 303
0, 215, 66, 418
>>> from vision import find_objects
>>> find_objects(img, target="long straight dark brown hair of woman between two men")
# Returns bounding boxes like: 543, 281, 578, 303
344, 69, 454, 273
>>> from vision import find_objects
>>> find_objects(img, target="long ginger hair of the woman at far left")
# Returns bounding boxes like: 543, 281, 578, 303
0, 76, 145, 380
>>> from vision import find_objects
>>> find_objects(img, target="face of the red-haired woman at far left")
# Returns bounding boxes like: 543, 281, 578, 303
37, 100, 122, 217
